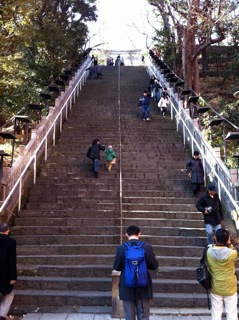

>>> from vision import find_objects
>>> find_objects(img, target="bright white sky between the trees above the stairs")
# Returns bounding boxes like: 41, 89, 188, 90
88, 0, 154, 51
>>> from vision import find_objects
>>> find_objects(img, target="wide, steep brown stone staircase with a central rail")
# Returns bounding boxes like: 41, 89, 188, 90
11, 67, 210, 312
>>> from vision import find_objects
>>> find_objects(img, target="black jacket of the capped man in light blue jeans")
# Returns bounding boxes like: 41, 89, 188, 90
196, 191, 223, 226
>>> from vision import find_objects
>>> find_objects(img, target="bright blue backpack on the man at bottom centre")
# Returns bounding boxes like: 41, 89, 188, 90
124, 241, 148, 288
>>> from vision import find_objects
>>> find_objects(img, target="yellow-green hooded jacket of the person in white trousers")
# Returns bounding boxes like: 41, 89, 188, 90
206, 245, 238, 296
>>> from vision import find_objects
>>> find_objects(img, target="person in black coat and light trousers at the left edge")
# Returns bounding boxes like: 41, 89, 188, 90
0, 222, 17, 320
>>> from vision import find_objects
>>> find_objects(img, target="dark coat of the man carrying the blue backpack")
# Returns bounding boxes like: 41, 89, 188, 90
113, 239, 158, 300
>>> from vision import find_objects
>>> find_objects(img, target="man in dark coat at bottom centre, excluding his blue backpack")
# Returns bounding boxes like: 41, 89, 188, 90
113, 226, 158, 320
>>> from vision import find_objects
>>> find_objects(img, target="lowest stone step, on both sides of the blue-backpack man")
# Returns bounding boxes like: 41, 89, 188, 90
13, 290, 207, 313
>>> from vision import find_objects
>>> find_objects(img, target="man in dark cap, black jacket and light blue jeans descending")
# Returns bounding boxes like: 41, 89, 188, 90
196, 184, 224, 244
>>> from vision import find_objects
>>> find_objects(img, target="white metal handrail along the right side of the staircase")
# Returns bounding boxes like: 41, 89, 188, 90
147, 60, 239, 229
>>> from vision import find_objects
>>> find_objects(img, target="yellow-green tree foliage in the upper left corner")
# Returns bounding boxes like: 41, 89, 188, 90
0, 0, 97, 118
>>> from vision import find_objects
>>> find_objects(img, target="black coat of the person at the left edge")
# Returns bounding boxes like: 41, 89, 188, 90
0, 234, 17, 294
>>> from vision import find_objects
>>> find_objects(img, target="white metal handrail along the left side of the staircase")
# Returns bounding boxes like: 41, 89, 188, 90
0, 57, 92, 214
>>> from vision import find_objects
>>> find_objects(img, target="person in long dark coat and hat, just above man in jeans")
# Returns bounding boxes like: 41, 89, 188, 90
186, 151, 204, 195
